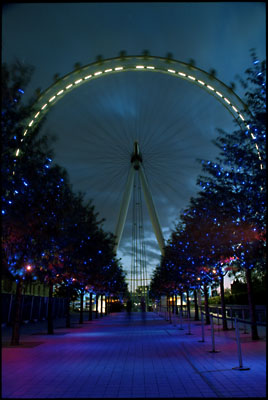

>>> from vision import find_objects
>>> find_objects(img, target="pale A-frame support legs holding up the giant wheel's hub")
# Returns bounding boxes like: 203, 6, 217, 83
115, 142, 165, 255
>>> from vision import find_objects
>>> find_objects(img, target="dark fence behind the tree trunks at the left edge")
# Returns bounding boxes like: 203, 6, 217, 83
1, 293, 66, 325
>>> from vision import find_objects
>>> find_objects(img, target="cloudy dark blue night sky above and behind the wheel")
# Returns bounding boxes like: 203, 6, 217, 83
2, 2, 266, 284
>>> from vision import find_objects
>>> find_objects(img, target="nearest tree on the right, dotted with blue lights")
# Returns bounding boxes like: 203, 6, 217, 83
196, 52, 266, 339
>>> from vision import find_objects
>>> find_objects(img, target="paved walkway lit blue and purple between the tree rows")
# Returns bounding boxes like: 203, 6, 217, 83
2, 312, 266, 398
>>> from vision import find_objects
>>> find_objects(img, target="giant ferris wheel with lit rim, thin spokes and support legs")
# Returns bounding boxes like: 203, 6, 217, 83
16, 56, 262, 296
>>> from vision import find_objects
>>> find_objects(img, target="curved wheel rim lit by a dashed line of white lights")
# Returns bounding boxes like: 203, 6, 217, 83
15, 56, 263, 169
